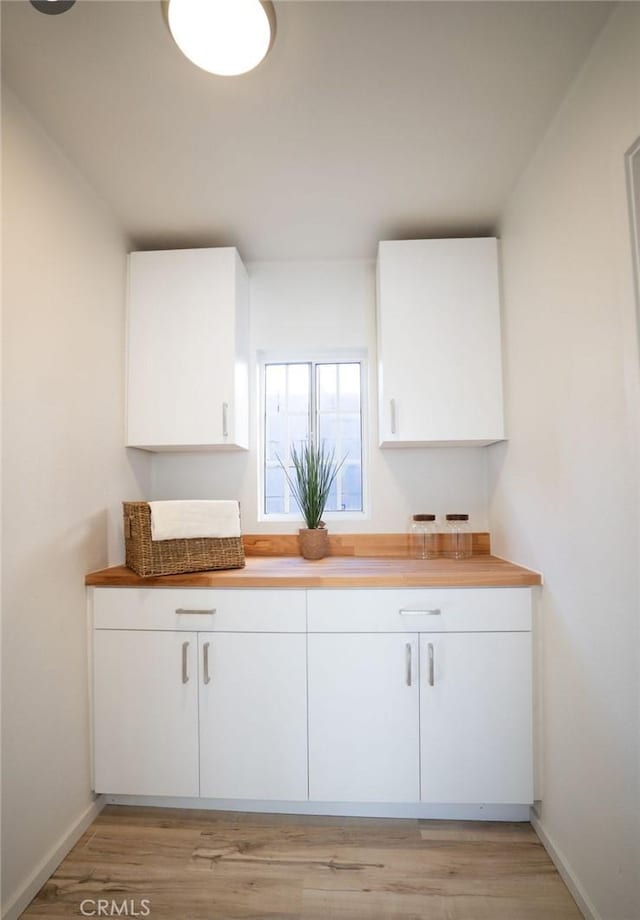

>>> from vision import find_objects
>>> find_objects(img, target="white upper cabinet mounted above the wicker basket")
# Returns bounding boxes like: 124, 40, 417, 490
127, 247, 249, 451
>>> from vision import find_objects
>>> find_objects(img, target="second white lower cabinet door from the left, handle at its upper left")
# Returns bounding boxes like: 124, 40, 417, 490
199, 633, 307, 801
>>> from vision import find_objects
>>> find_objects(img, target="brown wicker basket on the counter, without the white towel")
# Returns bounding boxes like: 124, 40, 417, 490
122, 502, 244, 575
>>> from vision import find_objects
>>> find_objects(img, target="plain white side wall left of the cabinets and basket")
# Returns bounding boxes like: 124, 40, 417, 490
2, 93, 149, 912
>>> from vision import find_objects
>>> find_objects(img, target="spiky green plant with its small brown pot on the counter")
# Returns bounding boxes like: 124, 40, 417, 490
278, 441, 344, 559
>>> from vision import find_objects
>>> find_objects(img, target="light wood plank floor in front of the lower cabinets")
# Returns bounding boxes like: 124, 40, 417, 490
22, 806, 581, 920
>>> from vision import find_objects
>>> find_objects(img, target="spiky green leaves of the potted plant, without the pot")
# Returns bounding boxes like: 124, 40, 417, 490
278, 441, 346, 530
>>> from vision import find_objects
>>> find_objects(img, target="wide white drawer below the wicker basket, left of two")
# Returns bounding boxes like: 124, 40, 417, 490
93, 588, 306, 632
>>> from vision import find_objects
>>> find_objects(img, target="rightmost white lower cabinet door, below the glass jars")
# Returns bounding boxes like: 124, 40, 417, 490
420, 632, 533, 804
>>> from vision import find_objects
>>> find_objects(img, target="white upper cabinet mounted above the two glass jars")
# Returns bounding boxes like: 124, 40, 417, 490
377, 238, 504, 447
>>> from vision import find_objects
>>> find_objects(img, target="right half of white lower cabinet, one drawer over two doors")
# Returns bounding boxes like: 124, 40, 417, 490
307, 588, 533, 805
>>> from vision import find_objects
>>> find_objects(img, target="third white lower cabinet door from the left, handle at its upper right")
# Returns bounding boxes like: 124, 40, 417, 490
308, 634, 420, 802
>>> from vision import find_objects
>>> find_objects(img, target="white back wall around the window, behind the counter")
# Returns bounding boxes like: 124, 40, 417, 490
152, 261, 487, 533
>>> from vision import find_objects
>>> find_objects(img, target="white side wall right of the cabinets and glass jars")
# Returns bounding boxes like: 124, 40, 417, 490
489, 3, 640, 920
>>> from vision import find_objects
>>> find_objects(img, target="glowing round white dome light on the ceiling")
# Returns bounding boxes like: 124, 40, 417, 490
168, 0, 271, 77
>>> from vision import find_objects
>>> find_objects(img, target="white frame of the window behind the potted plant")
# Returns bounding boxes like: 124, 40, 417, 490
257, 349, 370, 524
